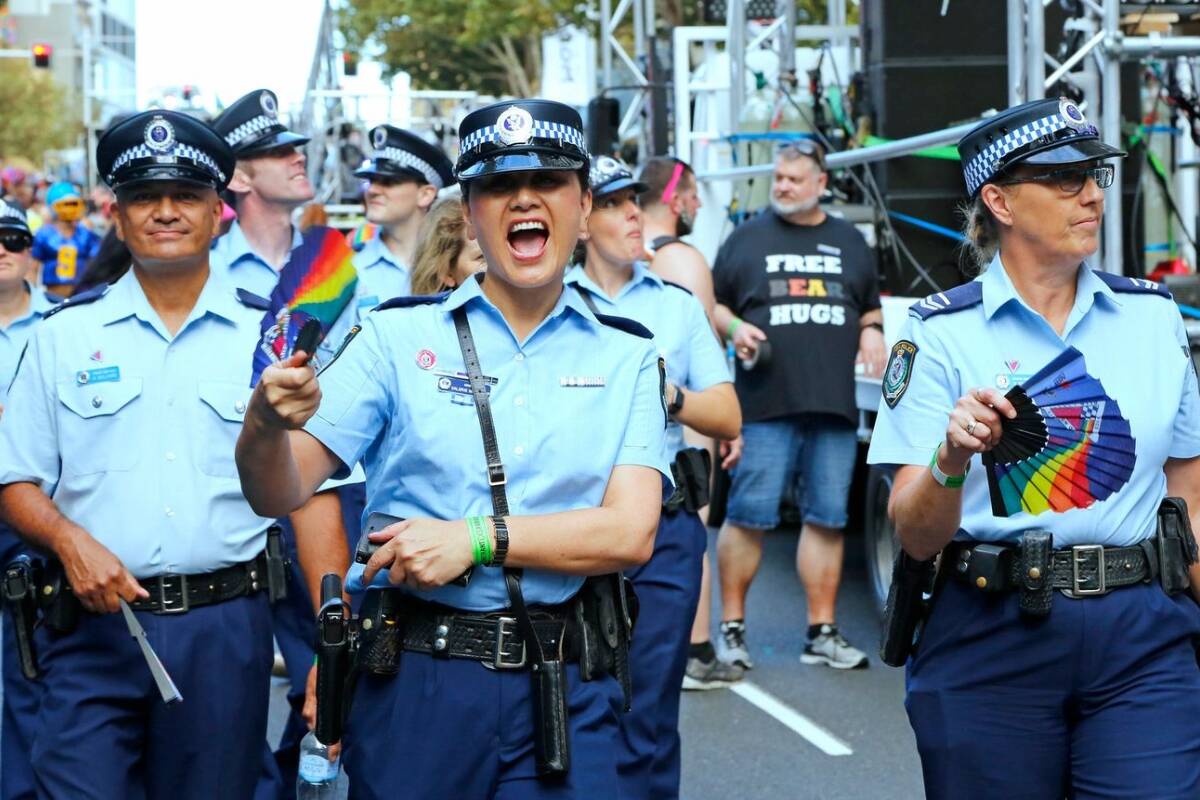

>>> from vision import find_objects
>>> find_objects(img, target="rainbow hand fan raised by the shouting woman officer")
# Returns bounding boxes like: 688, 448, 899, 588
251, 225, 359, 386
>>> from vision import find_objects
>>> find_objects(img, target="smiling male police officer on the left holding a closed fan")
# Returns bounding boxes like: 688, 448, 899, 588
0, 112, 280, 798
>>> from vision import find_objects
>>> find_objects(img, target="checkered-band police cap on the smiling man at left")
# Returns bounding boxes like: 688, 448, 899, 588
96, 110, 234, 191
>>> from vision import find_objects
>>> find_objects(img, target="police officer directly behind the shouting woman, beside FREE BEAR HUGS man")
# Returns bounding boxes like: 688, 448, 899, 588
566, 156, 742, 799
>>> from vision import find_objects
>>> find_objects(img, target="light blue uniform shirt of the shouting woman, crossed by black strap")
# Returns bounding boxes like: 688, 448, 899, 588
306, 273, 670, 610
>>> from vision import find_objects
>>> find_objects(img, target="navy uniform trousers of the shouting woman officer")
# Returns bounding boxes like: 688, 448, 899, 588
342, 652, 623, 800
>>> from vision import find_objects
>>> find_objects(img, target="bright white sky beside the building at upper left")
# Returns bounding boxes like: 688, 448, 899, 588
137, 0, 324, 110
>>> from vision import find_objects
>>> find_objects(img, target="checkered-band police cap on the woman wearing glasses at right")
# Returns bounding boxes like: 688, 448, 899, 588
959, 97, 1126, 197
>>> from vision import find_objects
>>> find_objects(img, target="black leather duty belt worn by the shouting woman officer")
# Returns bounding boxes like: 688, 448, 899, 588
379, 590, 578, 669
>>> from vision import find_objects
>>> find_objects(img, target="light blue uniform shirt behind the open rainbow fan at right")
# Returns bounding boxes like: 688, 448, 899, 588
868, 257, 1200, 547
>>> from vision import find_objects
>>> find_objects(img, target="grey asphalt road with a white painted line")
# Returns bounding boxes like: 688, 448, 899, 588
0, 531, 923, 800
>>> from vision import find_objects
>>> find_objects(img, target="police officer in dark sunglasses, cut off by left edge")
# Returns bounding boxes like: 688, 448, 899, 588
0, 200, 61, 800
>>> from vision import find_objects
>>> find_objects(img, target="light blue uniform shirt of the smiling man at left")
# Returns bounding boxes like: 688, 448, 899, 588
0, 270, 271, 577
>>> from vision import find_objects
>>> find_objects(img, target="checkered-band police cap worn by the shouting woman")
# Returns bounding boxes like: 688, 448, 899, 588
455, 100, 590, 181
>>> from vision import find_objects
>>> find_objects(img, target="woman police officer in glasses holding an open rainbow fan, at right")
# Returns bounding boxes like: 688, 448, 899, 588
869, 100, 1200, 800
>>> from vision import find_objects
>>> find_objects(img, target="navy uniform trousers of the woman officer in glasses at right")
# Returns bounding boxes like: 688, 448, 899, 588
906, 582, 1200, 800
